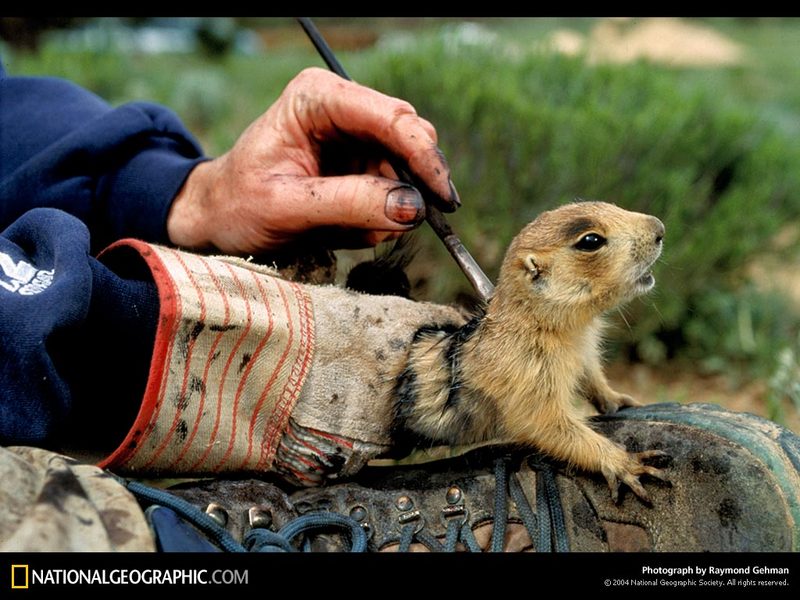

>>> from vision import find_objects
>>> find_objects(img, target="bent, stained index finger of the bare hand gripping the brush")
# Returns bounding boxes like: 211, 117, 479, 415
290, 69, 460, 208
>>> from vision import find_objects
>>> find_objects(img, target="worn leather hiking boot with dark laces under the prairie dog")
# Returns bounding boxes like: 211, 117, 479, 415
158, 404, 800, 552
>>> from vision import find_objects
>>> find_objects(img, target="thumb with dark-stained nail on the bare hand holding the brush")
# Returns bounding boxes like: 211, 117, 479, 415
284, 175, 425, 231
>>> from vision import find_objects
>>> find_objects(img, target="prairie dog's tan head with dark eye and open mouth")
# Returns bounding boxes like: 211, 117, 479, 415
496, 202, 664, 316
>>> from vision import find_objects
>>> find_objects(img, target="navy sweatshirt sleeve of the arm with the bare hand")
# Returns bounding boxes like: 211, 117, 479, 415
0, 66, 206, 251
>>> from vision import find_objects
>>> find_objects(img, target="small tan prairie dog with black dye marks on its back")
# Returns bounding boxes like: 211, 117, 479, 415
395, 202, 664, 501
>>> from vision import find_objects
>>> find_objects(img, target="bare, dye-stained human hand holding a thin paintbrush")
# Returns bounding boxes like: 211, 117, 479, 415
167, 68, 460, 254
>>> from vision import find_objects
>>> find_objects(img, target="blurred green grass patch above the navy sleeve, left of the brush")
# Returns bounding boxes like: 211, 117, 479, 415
6, 44, 319, 156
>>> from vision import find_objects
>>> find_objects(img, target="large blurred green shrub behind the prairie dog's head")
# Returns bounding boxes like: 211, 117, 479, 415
359, 41, 800, 366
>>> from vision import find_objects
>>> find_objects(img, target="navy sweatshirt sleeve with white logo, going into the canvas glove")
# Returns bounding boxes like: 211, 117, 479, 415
0, 208, 160, 446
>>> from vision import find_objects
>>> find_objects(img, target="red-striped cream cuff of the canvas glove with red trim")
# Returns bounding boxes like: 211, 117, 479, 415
100, 240, 314, 473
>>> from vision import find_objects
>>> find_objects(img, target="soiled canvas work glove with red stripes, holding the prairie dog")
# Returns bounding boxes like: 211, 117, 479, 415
101, 240, 463, 485
